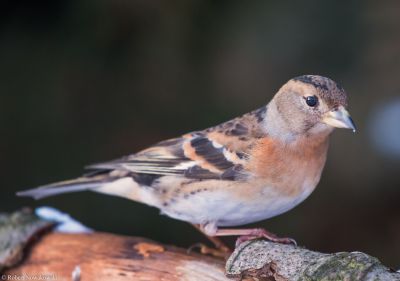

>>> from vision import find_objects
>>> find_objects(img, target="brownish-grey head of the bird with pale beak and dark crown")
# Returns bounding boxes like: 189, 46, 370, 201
269, 75, 356, 135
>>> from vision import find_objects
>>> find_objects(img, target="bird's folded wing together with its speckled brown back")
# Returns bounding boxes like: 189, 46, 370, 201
87, 108, 265, 180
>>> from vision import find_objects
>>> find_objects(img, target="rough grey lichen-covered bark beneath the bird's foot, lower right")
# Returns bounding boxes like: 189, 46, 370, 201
226, 240, 400, 281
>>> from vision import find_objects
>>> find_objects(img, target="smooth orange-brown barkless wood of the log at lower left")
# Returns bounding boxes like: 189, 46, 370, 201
3, 233, 229, 281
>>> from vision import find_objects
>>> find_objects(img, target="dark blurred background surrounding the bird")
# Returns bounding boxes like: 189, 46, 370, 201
0, 0, 400, 267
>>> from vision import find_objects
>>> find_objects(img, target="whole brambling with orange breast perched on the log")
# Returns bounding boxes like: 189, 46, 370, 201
18, 75, 355, 247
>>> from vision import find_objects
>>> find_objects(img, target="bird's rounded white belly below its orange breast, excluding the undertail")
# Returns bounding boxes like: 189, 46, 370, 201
162, 182, 314, 226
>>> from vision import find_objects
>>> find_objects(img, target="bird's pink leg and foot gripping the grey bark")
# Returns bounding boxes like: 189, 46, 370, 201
215, 228, 297, 247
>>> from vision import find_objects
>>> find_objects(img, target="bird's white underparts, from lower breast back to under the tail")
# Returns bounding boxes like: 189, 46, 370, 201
95, 174, 318, 226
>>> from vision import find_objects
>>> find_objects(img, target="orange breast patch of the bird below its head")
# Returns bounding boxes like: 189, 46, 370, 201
246, 136, 328, 197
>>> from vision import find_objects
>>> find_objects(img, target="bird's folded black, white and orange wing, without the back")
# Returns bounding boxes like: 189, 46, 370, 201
87, 133, 243, 180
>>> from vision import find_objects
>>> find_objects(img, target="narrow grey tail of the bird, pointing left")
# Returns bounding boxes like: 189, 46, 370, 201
17, 175, 115, 199
